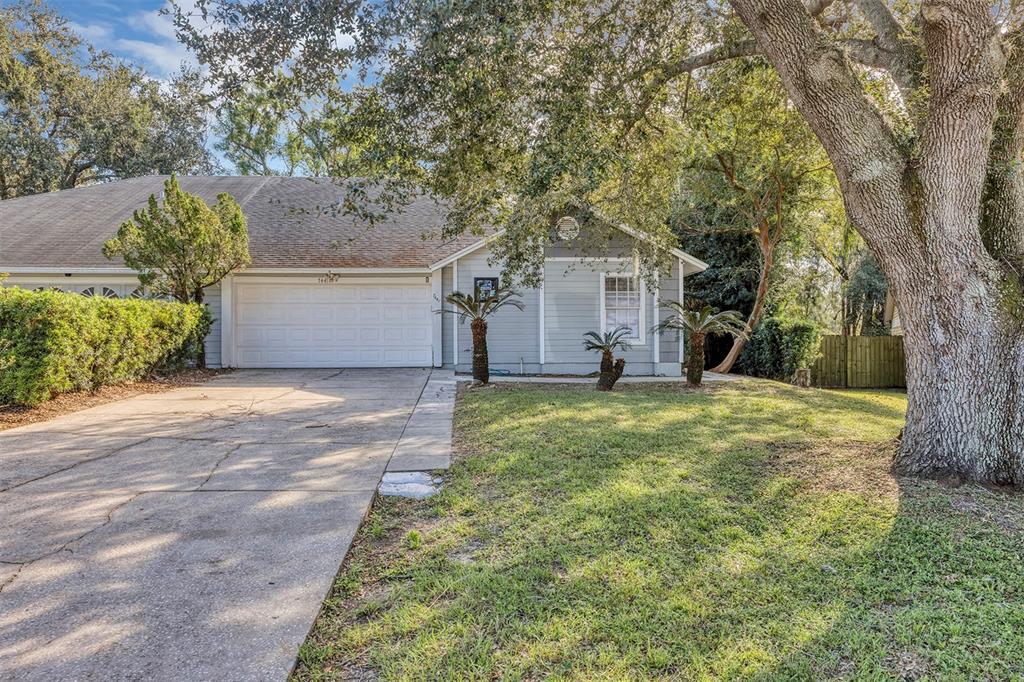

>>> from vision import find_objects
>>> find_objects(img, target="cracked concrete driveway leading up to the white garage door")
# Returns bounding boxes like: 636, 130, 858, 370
0, 370, 451, 680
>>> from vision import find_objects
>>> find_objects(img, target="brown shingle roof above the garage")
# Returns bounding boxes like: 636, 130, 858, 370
0, 175, 491, 271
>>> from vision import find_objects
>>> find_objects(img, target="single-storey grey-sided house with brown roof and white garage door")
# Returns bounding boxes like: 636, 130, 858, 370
0, 176, 707, 375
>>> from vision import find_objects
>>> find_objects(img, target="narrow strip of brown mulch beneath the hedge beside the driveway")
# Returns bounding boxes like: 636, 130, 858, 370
0, 370, 230, 431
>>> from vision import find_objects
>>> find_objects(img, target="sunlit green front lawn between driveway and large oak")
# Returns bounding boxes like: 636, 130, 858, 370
295, 382, 1024, 680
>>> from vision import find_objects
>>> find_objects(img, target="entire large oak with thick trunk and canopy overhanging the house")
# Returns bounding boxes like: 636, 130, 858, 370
176, 0, 1024, 485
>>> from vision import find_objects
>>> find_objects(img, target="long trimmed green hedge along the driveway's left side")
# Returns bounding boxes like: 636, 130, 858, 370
0, 287, 210, 404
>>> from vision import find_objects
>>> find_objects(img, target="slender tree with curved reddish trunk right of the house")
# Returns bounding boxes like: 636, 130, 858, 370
675, 62, 831, 373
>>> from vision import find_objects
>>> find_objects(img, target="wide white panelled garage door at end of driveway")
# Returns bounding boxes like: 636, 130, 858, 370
234, 281, 433, 368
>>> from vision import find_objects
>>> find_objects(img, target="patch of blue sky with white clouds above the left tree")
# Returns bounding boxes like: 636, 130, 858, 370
49, 0, 194, 78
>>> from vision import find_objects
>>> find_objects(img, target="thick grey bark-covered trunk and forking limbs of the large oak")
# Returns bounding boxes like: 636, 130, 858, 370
730, 0, 1024, 485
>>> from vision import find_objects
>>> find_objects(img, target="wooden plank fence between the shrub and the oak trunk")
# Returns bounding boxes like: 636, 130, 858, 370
811, 336, 906, 388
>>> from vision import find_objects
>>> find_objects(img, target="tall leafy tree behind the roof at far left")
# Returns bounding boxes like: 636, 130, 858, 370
0, 1, 213, 199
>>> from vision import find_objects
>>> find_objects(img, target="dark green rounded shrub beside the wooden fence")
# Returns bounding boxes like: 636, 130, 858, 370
739, 317, 821, 381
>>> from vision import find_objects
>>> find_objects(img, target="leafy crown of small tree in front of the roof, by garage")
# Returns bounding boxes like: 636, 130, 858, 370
103, 175, 250, 303
